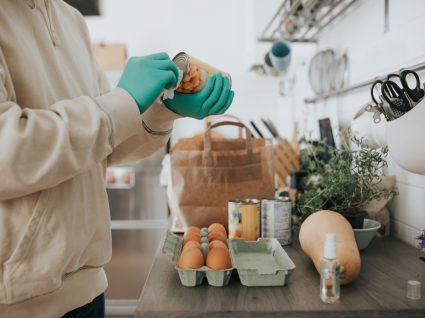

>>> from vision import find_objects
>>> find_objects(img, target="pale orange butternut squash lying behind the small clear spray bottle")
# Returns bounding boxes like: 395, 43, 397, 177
299, 211, 361, 285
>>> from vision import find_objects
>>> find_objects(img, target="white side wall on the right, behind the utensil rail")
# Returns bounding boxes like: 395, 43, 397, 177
297, 0, 425, 245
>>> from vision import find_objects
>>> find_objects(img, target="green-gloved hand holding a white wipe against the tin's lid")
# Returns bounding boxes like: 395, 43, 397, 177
118, 53, 179, 113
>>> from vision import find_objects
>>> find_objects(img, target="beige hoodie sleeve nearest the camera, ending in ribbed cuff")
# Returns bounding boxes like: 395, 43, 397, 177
0, 48, 142, 200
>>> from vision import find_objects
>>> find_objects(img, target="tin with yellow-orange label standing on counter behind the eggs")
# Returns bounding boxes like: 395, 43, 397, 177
228, 199, 260, 241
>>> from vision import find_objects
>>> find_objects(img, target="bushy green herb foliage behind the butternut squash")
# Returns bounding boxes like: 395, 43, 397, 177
296, 132, 396, 229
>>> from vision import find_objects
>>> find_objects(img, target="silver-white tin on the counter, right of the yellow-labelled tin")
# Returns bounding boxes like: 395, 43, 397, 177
261, 198, 292, 245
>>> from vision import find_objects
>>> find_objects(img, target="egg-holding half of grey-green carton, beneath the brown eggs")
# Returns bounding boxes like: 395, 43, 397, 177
162, 231, 234, 287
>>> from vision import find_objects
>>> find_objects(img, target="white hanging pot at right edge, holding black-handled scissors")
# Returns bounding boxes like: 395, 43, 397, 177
386, 99, 425, 175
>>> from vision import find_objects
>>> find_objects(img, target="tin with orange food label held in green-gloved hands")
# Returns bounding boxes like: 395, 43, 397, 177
173, 52, 232, 93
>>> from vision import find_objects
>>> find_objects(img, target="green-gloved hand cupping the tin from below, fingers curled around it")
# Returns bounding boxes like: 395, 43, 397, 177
164, 73, 235, 119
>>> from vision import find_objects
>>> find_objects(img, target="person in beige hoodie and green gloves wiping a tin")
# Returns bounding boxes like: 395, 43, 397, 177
0, 0, 233, 318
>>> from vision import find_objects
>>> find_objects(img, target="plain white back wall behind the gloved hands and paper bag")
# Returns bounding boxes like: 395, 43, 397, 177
86, 0, 292, 141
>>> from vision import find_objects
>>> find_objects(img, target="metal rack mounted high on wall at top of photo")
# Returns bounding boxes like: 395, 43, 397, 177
258, 0, 357, 43
